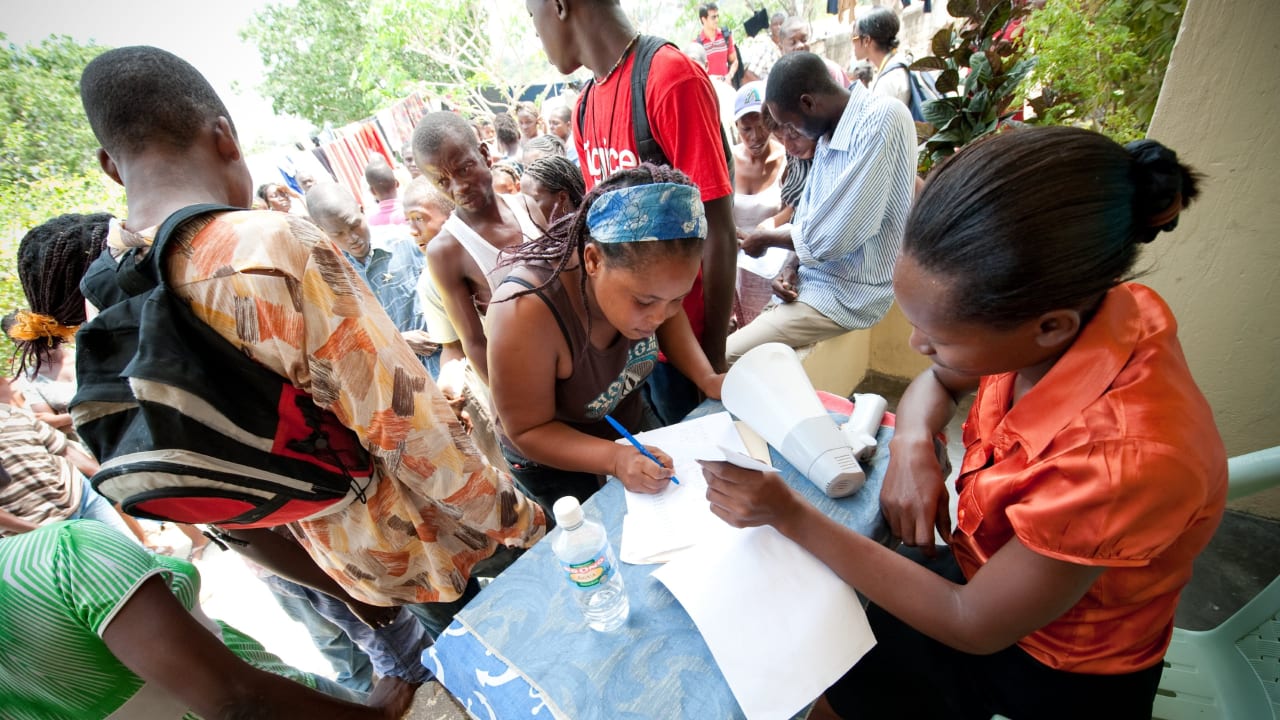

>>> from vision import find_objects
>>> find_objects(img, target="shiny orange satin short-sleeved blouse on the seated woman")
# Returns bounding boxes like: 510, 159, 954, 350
952, 283, 1226, 674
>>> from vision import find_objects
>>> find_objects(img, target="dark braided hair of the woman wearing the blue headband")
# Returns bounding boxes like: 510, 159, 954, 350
499, 163, 703, 322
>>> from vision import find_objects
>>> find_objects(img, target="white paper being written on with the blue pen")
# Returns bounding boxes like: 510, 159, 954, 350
618, 413, 746, 565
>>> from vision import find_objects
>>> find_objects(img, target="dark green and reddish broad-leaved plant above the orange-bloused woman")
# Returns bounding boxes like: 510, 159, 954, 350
911, 0, 1036, 172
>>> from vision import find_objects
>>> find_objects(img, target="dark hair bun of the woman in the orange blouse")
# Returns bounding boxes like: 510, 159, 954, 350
1125, 140, 1199, 242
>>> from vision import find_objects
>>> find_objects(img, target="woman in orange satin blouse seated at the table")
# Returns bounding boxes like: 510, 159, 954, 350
707, 127, 1226, 719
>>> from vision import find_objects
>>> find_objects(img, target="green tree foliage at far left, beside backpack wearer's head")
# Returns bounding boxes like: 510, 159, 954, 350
0, 33, 106, 184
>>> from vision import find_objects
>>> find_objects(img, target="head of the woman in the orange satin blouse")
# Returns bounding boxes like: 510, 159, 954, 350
895, 127, 1197, 374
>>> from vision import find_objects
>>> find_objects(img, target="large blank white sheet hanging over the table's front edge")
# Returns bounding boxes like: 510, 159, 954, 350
653, 527, 876, 720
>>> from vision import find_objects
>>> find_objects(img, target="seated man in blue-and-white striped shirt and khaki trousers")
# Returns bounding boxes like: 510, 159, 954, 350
726, 53, 915, 364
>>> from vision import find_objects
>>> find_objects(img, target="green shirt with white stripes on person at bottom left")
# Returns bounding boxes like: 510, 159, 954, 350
0, 520, 315, 720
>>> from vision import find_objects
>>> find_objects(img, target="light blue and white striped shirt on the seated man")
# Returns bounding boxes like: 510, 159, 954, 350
791, 83, 915, 329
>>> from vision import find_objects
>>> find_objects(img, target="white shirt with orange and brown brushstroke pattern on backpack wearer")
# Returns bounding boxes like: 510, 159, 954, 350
124, 211, 545, 605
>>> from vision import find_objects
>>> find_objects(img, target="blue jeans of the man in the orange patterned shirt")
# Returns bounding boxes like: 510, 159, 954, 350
266, 575, 431, 689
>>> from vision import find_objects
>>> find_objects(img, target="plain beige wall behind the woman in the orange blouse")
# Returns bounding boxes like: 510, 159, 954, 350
1139, 0, 1280, 455
